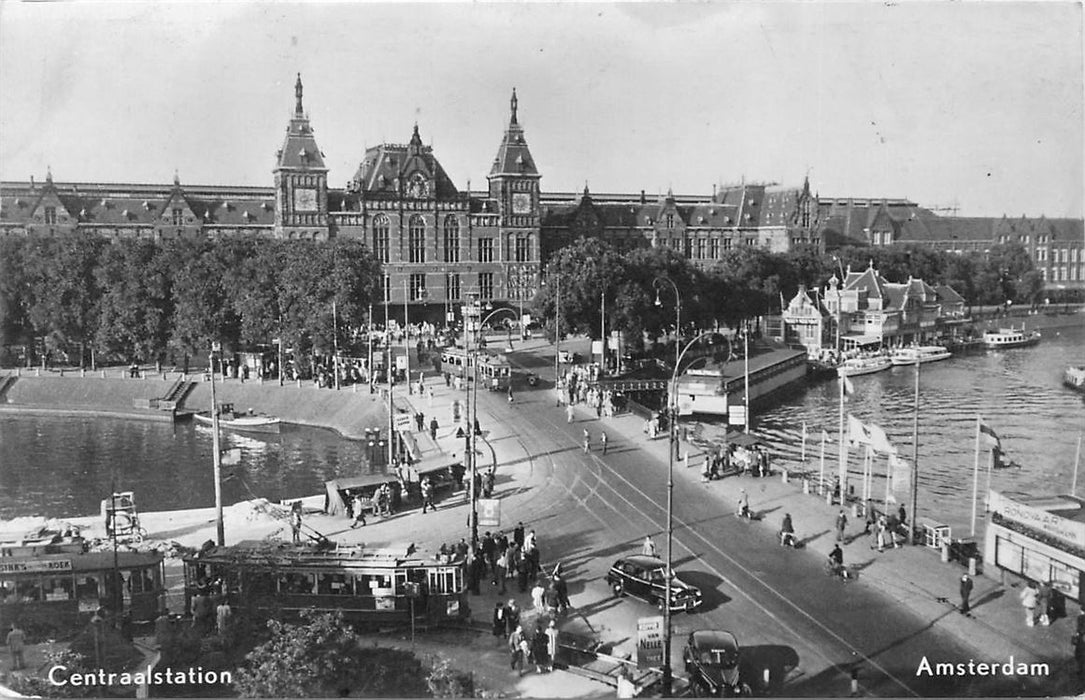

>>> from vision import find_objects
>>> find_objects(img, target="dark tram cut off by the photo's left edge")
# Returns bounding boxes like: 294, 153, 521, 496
0, 551, 166, 634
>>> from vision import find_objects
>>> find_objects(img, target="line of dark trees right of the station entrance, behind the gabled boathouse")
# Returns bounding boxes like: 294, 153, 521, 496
535, 239, 1043, 349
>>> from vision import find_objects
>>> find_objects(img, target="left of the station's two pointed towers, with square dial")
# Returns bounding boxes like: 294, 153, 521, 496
273, 73, 329, 241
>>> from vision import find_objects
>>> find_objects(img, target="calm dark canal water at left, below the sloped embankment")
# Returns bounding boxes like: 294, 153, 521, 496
0, 413, 369, 519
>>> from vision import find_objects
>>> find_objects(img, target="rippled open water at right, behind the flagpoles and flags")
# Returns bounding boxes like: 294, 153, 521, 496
702, 326, 1085, 536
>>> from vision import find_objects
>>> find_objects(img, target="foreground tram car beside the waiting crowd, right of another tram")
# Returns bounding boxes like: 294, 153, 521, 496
184, 540, 470, 625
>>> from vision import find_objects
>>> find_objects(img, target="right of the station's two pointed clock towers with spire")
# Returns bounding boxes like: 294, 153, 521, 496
487, 88, 541, 223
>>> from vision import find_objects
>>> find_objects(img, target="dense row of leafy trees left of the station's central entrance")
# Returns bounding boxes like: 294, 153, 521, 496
0, 237, 381, 365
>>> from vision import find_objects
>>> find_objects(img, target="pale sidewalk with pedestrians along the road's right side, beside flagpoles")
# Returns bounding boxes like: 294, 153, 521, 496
590, 399, 1078, 695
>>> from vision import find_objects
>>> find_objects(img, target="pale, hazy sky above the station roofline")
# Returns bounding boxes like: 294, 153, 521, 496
0, 1, 1085, 217
